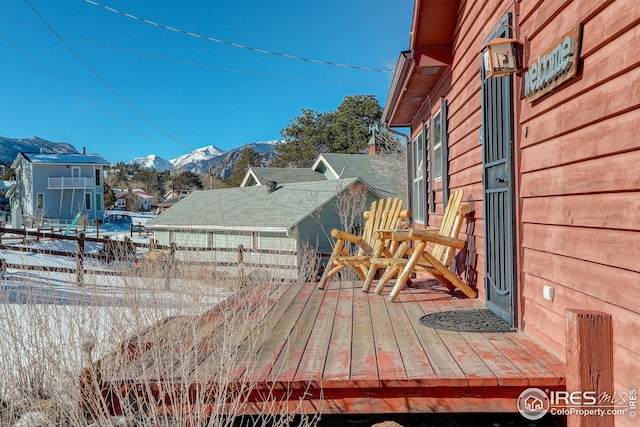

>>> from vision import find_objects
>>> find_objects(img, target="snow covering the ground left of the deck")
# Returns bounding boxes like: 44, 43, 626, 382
0, 216, 228, 399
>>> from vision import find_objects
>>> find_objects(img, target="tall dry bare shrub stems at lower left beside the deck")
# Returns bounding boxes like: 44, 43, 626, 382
0, 236, 317, 427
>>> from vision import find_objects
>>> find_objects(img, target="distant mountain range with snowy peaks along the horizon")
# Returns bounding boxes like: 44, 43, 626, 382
0, 136, 280, 178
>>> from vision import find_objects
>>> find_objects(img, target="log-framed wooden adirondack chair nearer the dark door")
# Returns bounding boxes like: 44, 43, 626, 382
369, 190, 478, 301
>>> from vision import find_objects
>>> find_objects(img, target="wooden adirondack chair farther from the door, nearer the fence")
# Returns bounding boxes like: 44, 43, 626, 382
318, 197, 411, 290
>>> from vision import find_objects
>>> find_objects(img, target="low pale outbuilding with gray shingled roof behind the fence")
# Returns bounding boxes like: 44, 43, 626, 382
146, 178, 380, 279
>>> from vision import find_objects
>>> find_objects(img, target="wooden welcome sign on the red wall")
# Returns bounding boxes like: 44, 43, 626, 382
524, 26, 581, 102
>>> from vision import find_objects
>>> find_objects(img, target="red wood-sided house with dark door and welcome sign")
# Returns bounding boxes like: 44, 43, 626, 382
383, 0, 640, 414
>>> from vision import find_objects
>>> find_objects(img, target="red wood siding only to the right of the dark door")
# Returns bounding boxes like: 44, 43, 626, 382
516, 0, 640, 425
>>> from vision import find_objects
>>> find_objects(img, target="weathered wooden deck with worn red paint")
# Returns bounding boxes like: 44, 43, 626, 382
85, 282, 565, 413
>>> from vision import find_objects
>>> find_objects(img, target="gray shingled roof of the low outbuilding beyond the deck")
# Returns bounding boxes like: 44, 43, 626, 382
147, 178, 378, 232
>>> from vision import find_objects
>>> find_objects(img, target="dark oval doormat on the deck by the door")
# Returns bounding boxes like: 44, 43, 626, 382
420, 309, 514, 332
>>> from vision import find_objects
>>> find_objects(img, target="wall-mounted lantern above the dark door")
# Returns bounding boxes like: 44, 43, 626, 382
482, 24, 523, 78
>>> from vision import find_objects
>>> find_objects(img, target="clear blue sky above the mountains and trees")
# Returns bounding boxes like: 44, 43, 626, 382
0, 0, 413, 163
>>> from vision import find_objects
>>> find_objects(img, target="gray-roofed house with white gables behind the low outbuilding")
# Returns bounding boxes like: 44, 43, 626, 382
240, 153, 406, 200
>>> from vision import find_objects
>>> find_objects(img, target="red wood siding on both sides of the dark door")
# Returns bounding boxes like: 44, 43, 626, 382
402, 0, 640, 425
